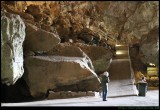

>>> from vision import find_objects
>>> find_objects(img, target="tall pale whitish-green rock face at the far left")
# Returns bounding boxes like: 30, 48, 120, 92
1, 12, 25, 85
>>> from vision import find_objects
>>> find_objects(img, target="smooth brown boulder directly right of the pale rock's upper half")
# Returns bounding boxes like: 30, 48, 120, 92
24, 23, 60, 51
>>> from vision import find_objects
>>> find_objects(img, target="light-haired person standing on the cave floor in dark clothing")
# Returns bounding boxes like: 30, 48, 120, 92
101, 71, 110, 101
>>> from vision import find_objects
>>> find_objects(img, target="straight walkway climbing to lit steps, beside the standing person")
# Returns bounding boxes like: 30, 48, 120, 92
108, 45, 137, 97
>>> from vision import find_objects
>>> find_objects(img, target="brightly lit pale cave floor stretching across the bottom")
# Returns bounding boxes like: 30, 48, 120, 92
1, 89, 159, 107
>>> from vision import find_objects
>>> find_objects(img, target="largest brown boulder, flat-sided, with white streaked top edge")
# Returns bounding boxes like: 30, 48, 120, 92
24, 56, 99, 98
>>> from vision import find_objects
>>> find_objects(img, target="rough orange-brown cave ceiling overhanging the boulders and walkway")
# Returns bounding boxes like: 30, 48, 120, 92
1, 1, 159, 67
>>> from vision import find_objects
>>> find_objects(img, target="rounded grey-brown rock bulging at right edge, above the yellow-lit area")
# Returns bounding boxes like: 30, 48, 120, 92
140, 28, 159, 66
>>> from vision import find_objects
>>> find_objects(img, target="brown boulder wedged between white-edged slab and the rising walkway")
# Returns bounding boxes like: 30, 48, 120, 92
76, 44, 113, 74
